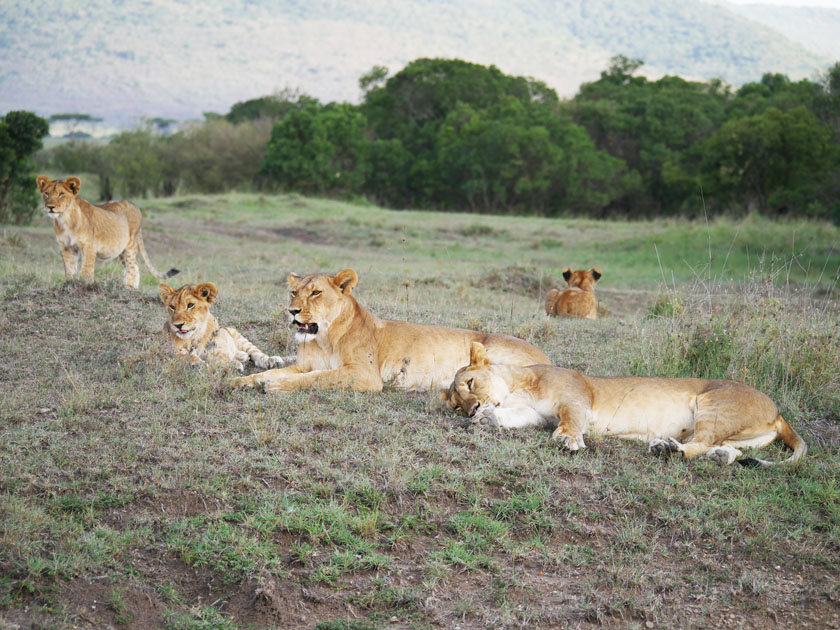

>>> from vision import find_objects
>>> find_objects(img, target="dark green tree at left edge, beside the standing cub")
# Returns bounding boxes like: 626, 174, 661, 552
0, 111, 49, 223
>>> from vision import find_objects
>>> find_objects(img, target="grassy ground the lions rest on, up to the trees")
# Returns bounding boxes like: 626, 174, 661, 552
0, 196, 840, 628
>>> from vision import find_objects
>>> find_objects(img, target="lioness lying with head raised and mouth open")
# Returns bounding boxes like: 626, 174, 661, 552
236, 269, 550, 392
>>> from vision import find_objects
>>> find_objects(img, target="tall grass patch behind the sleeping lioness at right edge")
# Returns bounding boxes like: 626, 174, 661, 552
631, 279, 840, 418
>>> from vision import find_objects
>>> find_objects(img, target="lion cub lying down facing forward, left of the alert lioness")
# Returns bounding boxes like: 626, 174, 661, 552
158, 282, 292, 370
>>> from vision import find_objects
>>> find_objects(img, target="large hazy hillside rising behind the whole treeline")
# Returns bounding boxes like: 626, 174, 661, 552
0, 0, 831, 123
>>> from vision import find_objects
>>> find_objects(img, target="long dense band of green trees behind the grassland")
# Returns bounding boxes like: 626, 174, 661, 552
32, 57, 840, 221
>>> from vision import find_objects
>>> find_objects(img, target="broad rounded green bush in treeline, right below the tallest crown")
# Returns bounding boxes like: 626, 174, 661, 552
438, 99, 625, 215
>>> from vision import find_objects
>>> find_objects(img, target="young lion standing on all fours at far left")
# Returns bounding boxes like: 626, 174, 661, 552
37, 175, 178, 288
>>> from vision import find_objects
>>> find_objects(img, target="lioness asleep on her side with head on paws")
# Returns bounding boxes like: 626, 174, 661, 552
441, 343, 807, 466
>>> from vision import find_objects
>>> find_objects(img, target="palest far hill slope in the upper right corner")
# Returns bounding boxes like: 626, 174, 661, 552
728, 4, 840, 60
